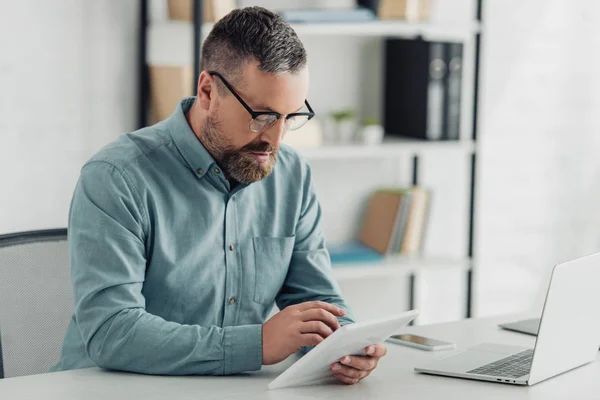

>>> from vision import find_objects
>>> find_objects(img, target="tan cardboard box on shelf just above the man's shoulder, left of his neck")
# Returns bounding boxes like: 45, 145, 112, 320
149, 65, 195, 124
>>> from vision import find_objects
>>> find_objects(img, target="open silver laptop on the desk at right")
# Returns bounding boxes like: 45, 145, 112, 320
415, 253, 600, 385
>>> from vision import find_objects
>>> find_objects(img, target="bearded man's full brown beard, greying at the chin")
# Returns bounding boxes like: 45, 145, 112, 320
202, 116, 278, 184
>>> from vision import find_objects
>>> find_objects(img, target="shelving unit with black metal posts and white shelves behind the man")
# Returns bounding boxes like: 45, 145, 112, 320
138, 0, 483, 318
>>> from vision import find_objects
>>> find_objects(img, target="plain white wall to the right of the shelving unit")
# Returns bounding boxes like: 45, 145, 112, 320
476, 0, 600, 315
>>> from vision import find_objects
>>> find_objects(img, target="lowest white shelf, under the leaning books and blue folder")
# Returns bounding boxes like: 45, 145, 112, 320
333, 256, 471, 280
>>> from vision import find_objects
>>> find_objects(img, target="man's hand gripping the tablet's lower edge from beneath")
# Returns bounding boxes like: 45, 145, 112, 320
331, 344, 387, 385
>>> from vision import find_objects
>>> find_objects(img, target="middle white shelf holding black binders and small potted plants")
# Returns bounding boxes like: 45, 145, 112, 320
296, 139, 475, 160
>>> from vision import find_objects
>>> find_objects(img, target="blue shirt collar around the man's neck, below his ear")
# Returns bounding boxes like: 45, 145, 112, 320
166, 97, 215, 178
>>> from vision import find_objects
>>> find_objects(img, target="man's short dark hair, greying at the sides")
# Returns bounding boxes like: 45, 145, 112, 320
201, 6, 306, 91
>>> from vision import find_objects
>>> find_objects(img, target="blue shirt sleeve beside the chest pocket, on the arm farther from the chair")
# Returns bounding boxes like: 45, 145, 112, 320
276, 164, 354, 325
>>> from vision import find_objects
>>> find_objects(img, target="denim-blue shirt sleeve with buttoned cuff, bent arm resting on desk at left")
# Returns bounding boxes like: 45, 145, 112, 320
68, 162, 262, 375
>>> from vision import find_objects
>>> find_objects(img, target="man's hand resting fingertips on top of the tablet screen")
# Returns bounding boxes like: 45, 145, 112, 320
262, 301, 344, 365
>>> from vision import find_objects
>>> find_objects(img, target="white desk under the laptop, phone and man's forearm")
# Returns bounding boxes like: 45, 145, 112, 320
0, 316, 600, 400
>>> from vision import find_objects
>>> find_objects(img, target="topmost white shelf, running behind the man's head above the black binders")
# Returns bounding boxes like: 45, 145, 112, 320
148, 19, 480, 65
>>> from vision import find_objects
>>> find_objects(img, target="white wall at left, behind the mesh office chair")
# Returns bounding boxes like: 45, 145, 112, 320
0, 0, 137, 234
